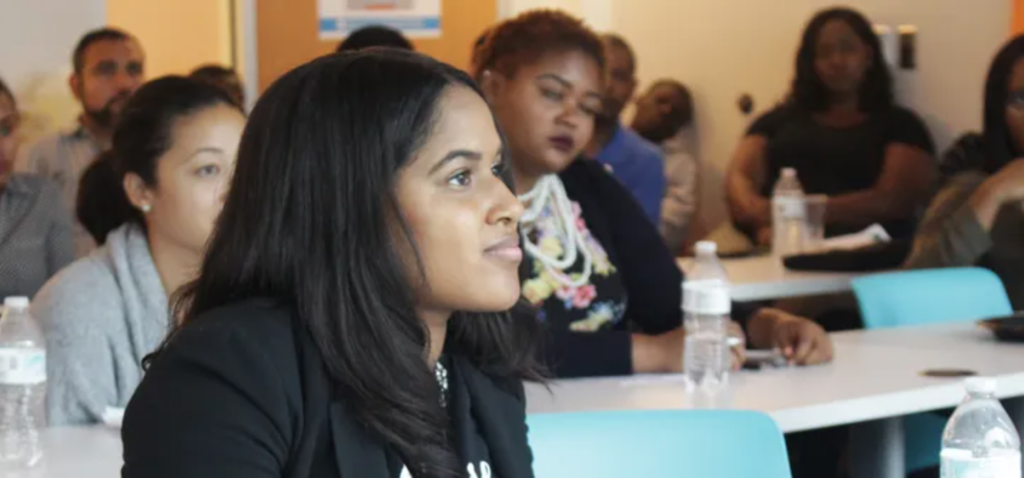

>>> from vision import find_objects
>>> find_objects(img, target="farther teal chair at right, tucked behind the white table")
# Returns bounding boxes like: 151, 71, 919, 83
852, 267, 1013, 471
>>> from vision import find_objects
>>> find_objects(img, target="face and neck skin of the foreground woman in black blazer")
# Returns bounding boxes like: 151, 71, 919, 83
395, 87, 523, 366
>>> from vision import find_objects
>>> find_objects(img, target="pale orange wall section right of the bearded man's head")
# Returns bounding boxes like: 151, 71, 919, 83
106, 0, 231, 78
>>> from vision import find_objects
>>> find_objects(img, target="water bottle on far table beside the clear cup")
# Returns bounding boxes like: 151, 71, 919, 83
771, 168, 807, 257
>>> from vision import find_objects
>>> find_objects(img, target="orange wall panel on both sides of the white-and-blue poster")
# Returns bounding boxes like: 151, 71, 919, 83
254, 0, 498, 90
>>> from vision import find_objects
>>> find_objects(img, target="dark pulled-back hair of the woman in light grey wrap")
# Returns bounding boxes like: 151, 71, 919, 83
75, 76, 241, 245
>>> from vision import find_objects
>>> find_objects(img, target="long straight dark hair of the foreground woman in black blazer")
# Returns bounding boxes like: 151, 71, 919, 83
169, 49, 540, 477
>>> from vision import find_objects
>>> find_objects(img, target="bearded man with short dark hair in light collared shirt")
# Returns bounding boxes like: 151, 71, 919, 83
18, 29, 145, 257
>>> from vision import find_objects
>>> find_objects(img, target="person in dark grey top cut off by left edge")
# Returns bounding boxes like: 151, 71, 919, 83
0, 76, 75, 301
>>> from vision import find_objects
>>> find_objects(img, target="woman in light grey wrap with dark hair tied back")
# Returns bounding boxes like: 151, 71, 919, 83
32, 77, 245, 425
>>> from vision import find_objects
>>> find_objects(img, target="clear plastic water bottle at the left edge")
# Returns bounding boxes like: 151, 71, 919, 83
0, 297, 46, 469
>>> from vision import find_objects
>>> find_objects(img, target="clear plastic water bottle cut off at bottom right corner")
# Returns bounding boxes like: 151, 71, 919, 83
941, 378, 1021, 478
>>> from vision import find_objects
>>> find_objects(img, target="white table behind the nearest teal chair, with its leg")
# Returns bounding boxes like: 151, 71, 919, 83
527, 323, 1024, 477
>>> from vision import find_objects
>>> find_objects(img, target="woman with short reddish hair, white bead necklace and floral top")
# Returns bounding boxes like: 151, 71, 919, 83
475, 10, 831, 377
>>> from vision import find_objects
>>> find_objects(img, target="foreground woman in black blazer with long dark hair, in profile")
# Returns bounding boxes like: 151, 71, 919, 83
122, 49, 539, 478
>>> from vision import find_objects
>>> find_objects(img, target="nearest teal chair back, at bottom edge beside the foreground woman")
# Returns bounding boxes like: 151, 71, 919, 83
526, 410, 792, 478
